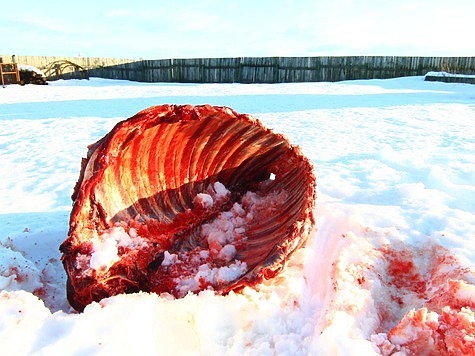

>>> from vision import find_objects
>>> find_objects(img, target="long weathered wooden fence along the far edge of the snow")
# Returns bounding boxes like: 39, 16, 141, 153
0, 56, 475, 83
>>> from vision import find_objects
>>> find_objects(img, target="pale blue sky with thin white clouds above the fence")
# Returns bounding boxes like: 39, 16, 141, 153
0, 0, 475, 59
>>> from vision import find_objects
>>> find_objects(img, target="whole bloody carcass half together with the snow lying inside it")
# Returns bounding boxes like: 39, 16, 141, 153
60, 105, 316, 310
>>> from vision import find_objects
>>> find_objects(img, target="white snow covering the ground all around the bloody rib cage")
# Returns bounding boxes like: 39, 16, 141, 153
0, 77, 475, 355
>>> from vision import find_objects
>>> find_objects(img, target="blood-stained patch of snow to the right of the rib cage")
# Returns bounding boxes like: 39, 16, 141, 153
371, 244, 475, 355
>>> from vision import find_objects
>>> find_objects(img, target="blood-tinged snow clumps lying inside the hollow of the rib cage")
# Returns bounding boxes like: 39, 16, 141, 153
82, 182, 287, 297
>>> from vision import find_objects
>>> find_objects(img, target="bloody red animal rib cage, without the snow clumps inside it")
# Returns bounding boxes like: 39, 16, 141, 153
60, 105, 316, 310
